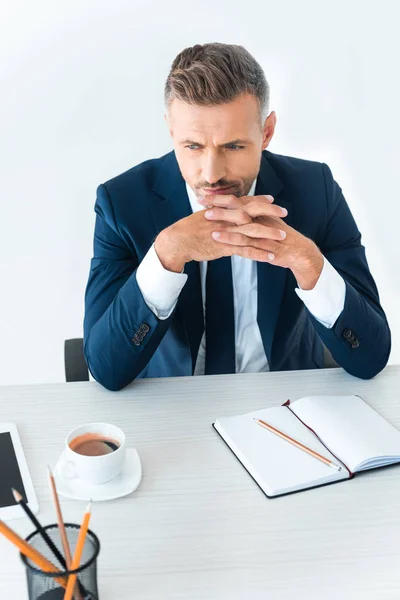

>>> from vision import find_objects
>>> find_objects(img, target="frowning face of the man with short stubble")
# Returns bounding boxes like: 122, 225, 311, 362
165, 94, 276, 198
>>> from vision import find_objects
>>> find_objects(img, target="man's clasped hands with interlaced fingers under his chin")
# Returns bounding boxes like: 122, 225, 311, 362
155, 194, 324, 290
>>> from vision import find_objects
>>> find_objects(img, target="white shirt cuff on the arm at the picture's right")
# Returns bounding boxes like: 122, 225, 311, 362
295, 257, 346, 329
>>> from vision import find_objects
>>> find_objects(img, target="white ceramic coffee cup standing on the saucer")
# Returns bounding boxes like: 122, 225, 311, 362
61, 423, 126, 483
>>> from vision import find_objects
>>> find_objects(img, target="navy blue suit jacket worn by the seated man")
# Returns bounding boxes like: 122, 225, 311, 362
84, 151, 390, 390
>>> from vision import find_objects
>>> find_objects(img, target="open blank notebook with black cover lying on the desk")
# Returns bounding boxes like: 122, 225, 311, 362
214, 396, 400, 497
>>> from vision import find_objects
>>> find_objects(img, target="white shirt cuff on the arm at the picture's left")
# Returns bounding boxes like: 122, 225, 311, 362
136, 244, 188, 320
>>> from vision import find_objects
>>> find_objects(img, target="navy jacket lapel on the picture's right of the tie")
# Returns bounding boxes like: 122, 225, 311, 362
255, 153, 292, 367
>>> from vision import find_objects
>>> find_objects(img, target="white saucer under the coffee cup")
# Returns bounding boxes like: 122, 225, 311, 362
54, 448, 142, 502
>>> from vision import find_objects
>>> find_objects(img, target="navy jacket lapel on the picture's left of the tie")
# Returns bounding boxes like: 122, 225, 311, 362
151, 152, 204, 373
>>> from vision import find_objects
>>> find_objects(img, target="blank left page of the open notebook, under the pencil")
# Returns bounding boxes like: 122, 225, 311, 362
214, 406, 349, 496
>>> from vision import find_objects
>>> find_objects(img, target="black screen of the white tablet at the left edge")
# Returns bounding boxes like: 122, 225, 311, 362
0, 431, 27, 508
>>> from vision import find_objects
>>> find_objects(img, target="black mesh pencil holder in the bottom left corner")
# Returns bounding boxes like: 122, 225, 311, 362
20, 523, 100, 600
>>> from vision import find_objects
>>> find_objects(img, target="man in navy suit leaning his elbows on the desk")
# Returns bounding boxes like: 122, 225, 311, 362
84, 43, 390, 390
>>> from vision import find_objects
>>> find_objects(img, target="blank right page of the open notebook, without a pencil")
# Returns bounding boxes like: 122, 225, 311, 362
290, 396, 400, 472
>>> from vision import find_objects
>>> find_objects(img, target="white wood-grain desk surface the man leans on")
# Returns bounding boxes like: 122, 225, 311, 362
0, 366, 400, 600
